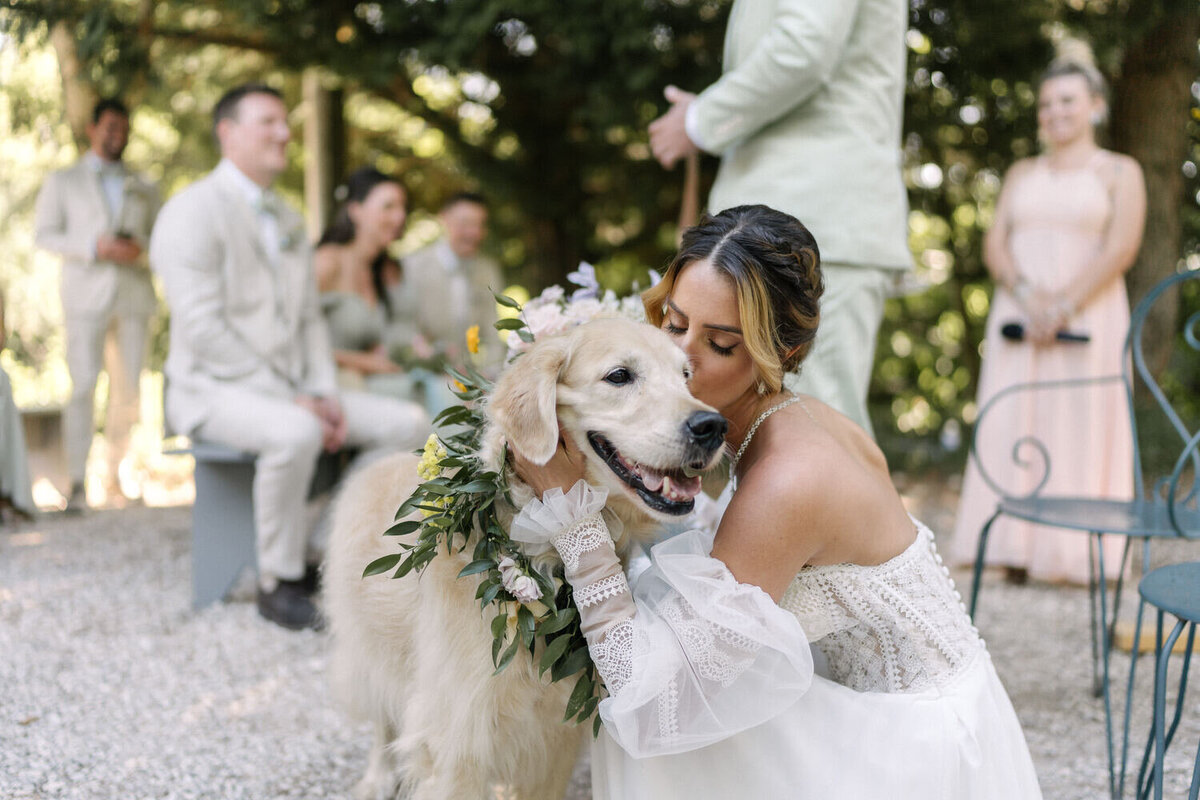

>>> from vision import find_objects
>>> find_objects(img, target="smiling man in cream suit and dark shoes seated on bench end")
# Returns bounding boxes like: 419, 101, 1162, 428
150, 84, 430, 628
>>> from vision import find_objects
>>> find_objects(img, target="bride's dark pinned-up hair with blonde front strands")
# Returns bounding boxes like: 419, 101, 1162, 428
642, 205, 824, 391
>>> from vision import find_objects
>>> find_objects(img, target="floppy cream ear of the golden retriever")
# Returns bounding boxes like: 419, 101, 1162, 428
488, 336, 570, 464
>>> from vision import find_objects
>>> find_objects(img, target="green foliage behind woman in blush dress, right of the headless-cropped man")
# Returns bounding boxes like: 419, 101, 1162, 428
871, 0, 1200, 464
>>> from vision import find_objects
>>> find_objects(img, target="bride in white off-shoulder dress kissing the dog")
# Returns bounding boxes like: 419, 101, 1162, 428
512, 205, 1040, 800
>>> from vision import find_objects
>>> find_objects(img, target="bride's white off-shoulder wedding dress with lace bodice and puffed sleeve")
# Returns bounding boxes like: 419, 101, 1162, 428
511, 483, 1042, 800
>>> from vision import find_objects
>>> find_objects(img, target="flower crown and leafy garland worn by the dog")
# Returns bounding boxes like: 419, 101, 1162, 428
362, 263, 658, 734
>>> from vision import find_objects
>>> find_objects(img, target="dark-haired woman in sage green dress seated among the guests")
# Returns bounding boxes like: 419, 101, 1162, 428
313, 167, 456, 416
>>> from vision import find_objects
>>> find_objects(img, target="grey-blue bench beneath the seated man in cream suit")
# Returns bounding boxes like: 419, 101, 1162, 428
164, 441, 355, 609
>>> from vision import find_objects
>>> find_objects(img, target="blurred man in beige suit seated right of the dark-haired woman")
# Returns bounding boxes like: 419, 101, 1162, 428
404, 192, 505, 372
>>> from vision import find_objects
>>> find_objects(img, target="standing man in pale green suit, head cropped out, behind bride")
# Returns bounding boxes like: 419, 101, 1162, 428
650, 0, 912, 431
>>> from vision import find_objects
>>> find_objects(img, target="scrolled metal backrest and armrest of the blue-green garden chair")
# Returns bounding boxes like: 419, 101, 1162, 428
971, 270, 1200, 525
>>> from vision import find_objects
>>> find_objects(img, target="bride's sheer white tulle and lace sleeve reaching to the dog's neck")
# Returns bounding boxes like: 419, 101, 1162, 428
514, 482, 812, 758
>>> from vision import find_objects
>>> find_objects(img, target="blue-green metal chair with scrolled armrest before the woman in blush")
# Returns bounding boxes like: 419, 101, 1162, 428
970, 271, 1200, 798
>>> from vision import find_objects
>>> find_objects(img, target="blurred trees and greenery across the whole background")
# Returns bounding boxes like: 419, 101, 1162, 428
0, 0, 1200, 470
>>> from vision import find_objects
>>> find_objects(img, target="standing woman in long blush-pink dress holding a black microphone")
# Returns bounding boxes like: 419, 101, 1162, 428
950, 58, 1146, 583
